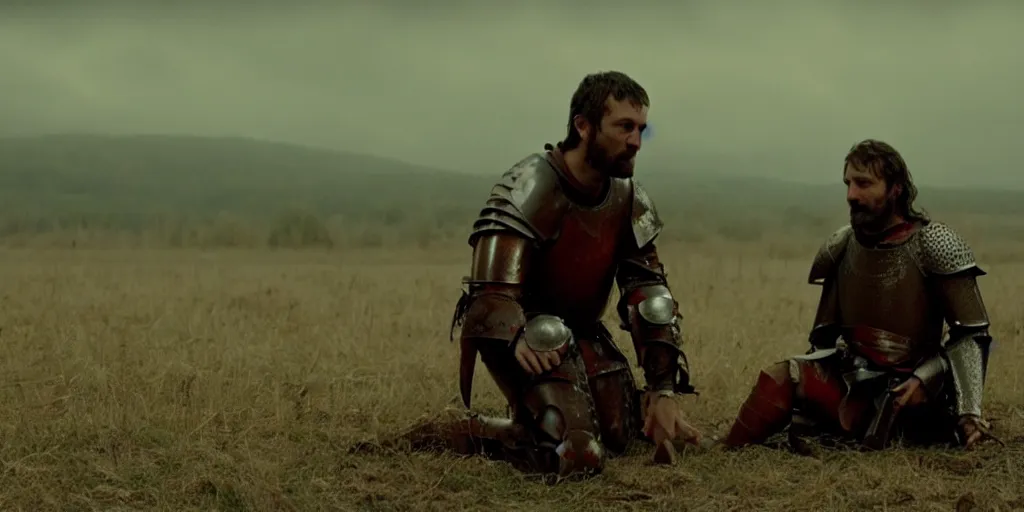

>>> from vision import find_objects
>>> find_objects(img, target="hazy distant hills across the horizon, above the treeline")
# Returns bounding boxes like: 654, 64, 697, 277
0, 135, 1024, 238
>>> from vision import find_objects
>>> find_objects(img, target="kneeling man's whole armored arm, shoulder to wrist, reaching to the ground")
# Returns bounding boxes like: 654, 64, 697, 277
615, 181, 695, 394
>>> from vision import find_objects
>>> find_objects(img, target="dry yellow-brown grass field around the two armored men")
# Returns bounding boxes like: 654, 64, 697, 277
0, 247, 1024, 511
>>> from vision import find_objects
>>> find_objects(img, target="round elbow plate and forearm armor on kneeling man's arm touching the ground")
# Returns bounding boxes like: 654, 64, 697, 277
623, 285, 693, 393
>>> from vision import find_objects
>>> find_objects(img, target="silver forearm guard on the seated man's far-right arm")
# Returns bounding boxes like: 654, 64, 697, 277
946, 332, 990, 417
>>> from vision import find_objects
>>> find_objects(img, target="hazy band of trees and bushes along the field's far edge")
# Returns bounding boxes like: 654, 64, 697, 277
0, 205, 833, 249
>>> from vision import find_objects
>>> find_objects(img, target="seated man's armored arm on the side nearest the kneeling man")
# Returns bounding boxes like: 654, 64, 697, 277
807, 226, 852, 352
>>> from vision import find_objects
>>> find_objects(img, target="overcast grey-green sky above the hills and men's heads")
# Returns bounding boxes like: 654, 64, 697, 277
0, 0, 1024, 187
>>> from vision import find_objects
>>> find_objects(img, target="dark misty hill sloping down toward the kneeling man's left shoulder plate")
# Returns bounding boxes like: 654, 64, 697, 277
0, 135, 486, 226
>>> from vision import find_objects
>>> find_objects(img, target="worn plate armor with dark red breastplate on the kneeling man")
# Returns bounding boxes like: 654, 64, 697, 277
436, 151, 692, 474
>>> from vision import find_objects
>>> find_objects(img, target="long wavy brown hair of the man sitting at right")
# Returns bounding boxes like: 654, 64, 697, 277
843, 138, 929, 222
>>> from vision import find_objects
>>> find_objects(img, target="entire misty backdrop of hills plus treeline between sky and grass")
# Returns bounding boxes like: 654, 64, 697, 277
0, 135, 1024, 248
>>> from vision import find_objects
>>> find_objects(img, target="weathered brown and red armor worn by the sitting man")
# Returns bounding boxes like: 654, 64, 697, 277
728, 222, 990, 445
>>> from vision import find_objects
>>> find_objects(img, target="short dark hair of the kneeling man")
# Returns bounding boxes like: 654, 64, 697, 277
558, 71, 650, 150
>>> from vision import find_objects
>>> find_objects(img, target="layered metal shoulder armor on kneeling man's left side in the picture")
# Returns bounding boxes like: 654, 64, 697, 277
469, 153, 569, 245
